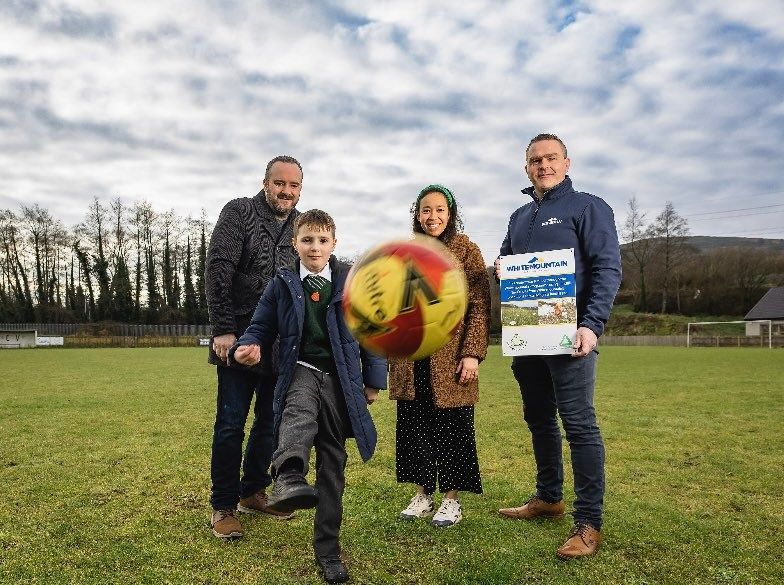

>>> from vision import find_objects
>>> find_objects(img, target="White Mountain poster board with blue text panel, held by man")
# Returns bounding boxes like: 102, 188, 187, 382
499, 248, 577, 356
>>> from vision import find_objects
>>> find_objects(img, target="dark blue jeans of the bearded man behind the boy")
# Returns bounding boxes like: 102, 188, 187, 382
210, 366, 275, 510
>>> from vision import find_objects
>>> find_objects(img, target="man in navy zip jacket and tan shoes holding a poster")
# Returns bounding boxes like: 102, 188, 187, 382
496, 134, 621, 559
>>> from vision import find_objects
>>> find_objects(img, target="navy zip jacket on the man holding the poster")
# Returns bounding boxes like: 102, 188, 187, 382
501, 176, 621, 337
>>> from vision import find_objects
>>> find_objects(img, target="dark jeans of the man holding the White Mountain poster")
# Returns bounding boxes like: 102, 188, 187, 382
512, 351, 604, 530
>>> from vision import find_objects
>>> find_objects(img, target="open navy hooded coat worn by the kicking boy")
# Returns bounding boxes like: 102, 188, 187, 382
232, 256, 387, 461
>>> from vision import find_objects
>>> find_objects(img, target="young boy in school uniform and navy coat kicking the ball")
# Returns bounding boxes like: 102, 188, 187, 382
230, 209, 387, 583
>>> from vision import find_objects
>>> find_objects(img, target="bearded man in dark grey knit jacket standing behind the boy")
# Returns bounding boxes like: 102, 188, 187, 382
205, 156, 303, 539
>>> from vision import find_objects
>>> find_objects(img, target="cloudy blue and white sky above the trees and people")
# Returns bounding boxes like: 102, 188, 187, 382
0, 0, 784, 262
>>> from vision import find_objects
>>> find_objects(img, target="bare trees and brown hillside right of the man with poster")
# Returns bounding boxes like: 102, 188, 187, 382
616, 198, 784, 315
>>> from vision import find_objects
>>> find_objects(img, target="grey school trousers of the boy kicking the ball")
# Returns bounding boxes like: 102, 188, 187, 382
272, 364, 351, 558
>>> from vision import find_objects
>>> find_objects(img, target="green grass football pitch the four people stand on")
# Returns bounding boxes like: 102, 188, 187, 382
0, 347, 784, 585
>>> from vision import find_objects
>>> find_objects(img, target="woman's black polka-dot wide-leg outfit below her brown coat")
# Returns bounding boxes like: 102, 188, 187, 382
395, 358, 482, 494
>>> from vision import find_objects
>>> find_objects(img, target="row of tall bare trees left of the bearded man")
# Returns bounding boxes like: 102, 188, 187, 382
0, 197, 211, 324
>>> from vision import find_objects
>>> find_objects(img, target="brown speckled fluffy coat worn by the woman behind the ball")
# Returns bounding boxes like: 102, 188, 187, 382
389, 234, 490, 408
